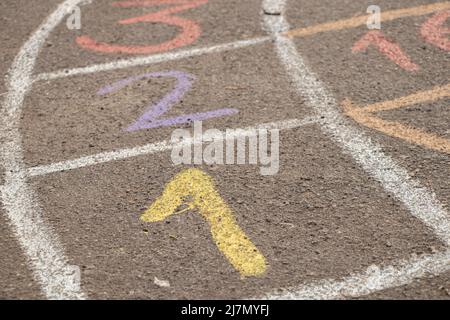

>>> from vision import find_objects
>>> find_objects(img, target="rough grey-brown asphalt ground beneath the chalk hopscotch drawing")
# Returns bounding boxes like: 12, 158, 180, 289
0, 0, 450, 299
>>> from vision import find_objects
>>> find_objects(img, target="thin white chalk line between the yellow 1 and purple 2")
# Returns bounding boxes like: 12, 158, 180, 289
27, 118, 320, 177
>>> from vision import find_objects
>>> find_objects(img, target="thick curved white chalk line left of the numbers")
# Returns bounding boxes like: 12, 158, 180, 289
0, 0, 86, 299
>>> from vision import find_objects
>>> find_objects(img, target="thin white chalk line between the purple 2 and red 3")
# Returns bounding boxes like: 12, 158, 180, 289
34, 36, 271, 81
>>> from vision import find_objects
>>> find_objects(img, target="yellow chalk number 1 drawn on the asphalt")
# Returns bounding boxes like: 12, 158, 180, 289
141, 169, 266, 276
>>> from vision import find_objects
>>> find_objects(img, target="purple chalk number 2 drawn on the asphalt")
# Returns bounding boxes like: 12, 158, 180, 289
98, 71, 239, 132
